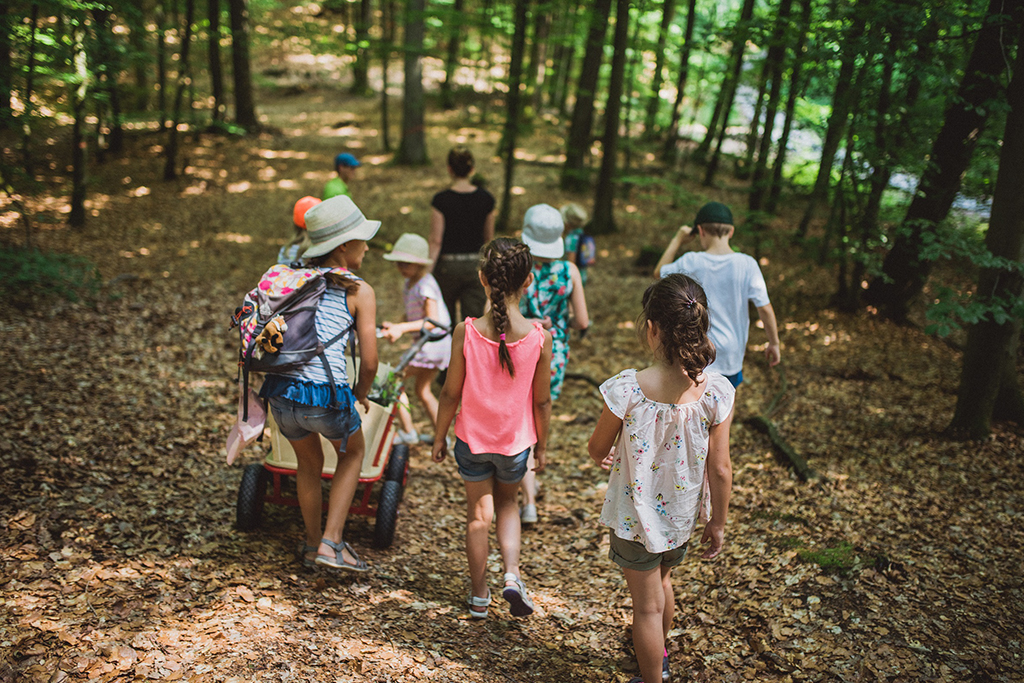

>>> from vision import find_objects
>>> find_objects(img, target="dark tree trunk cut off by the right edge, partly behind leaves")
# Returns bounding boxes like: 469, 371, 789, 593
949, 20, 1024, 439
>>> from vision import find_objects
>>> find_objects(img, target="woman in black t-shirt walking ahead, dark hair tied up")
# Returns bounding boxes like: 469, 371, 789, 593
429, 147, 496, 323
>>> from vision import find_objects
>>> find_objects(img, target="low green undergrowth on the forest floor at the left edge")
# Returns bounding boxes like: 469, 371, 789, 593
0, 248, 100, 306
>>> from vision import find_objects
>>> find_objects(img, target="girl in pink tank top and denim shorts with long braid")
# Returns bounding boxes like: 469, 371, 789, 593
433, 238, 551, 618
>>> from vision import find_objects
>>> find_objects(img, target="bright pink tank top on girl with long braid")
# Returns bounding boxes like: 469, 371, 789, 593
455, 317, 544, 456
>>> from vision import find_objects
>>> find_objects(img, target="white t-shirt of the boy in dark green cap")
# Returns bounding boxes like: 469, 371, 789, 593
659, 251, 771, 377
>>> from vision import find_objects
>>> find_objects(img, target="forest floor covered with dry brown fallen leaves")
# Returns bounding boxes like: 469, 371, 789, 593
0, 48, 1024, 683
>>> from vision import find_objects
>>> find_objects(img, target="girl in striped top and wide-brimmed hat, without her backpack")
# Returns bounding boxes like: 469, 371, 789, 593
260, 197, 380, 571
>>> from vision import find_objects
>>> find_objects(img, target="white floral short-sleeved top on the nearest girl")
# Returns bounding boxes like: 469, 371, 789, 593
601, 370, 736, 553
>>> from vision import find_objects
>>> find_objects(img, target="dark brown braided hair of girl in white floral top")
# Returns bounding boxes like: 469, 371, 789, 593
637, 273, 715, 384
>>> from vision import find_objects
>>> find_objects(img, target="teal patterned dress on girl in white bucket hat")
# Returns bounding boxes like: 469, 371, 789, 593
519, 261, 572, 400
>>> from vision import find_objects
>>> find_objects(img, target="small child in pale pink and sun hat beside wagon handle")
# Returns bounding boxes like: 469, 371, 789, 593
381, 232, 452, 443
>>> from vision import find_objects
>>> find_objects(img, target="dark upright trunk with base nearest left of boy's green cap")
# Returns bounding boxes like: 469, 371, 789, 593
590, 0, 630, 234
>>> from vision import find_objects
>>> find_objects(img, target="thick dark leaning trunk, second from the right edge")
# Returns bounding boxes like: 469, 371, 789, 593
865, 0, 1024, 322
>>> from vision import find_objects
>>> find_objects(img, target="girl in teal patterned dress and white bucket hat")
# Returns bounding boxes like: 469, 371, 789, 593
519, 204, 590, 524
